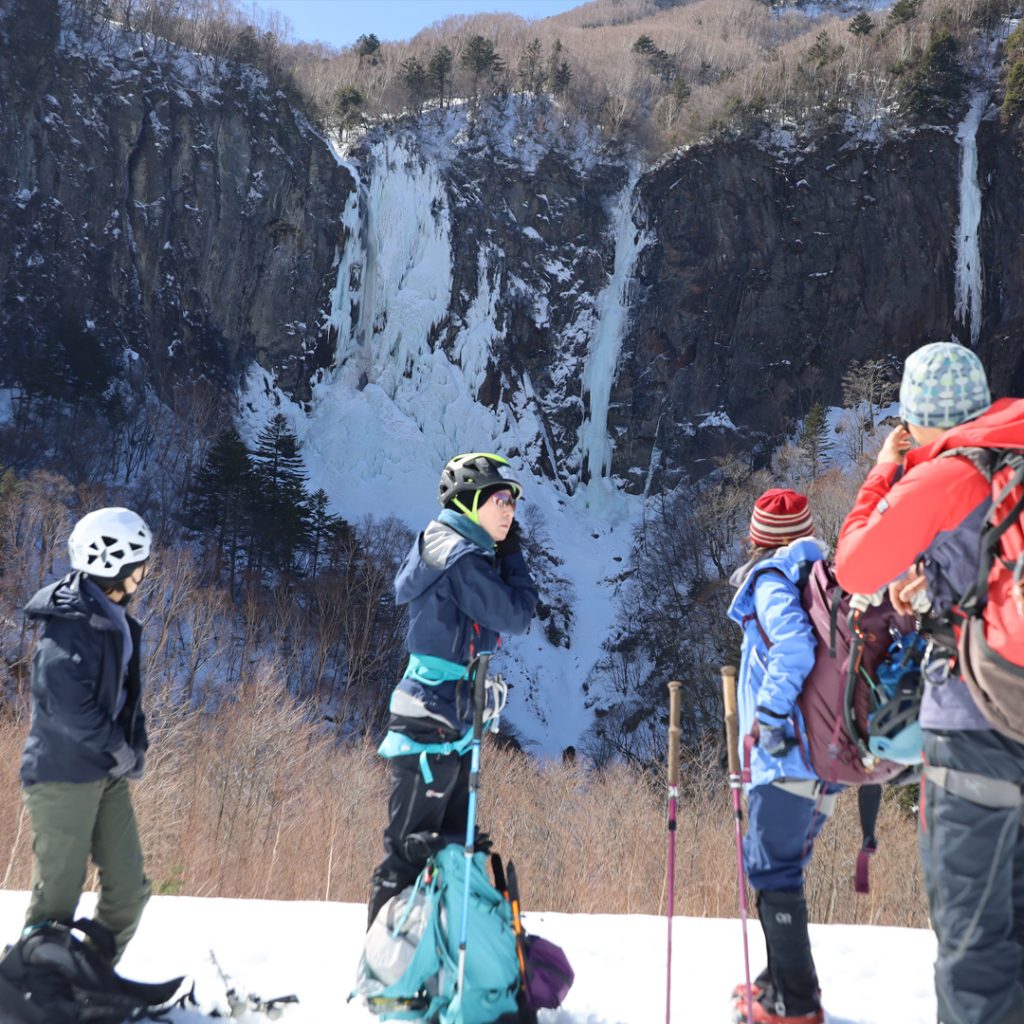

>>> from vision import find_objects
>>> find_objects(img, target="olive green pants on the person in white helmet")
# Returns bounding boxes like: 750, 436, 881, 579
24, 778, 152, 963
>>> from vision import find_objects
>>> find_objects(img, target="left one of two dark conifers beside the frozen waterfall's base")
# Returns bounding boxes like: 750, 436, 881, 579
185, 427, 256, 591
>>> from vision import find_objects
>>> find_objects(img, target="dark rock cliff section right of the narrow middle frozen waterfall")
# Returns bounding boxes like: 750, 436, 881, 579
615, 121, 1024, 487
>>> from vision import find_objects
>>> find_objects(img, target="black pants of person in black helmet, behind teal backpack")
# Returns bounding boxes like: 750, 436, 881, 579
368, 754, 470, 924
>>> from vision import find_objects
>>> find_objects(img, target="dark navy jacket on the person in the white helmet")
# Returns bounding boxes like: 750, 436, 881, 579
22, 572, 148, 785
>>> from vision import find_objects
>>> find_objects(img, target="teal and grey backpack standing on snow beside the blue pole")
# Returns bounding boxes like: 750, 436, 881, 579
349, 843, 519, 1024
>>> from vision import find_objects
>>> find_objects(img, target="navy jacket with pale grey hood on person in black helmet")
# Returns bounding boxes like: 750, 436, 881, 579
389, 509, 538, 741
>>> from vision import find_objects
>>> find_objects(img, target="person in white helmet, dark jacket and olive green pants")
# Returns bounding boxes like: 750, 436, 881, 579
22, 508, 153, 963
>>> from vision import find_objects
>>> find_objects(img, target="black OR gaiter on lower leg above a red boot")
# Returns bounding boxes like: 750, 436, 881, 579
758, 889, 821, 1017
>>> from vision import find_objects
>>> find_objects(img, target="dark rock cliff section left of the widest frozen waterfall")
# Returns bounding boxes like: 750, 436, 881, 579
0, 0, 353, 394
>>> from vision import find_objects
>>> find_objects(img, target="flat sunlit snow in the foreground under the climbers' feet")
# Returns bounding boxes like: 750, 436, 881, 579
0, 891, 935, 1024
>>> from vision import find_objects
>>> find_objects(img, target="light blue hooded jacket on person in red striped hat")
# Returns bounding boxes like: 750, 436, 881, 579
729, 538, 824, 785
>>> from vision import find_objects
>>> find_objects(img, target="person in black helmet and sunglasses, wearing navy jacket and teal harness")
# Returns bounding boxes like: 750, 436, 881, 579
368, 452, 538, 927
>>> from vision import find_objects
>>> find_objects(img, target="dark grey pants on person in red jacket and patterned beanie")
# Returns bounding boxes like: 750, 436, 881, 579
919, 729, 1024, 1024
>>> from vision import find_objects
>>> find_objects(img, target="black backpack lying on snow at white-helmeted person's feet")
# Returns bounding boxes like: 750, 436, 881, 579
0, 920, 184, 1024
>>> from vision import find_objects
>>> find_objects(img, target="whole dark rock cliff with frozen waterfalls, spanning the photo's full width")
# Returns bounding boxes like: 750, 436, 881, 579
0, 0, 1024, 493
